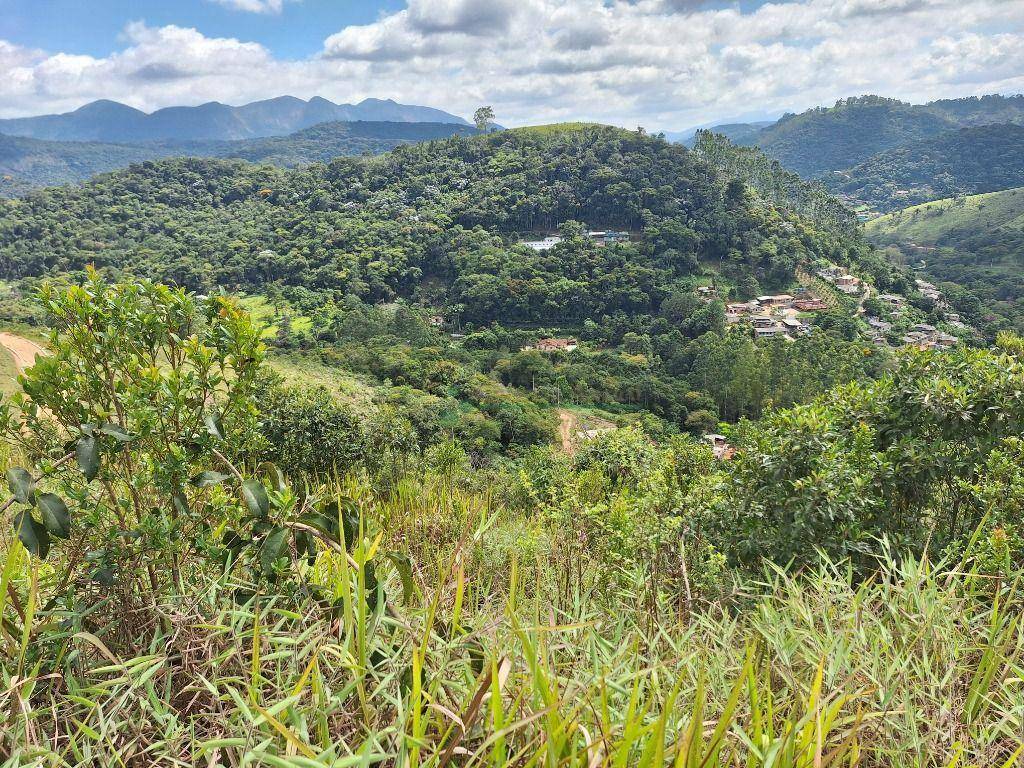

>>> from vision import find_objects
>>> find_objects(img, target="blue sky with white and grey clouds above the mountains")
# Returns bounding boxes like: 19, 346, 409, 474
0, 0, 1024, 131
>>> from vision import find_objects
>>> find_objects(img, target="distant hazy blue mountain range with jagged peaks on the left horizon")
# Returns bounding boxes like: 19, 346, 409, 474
0, 96, 469, 142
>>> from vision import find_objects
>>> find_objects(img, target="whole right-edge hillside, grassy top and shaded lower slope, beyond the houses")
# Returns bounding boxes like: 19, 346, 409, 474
865, 187, 1024, 329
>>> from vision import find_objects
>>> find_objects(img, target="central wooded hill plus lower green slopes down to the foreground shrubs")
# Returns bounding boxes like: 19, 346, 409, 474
0, 125, 905, 457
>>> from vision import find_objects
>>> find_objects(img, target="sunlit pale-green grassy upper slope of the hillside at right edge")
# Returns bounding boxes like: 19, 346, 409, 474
864, 187, 1024, 245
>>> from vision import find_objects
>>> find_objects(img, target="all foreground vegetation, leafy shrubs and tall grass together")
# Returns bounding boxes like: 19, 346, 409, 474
0, 276, 1024, 768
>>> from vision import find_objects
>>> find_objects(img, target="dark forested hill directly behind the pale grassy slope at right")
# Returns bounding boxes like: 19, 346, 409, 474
825, 123, 1024, 211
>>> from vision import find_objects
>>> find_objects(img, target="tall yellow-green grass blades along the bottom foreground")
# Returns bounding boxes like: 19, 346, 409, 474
0, 473, 1024, 768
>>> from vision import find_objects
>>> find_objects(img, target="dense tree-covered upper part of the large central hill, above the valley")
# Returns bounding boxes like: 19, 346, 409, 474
0, 126, 888, 322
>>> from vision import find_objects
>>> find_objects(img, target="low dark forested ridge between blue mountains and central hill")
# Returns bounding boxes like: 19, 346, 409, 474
0, 121, 477, 198
